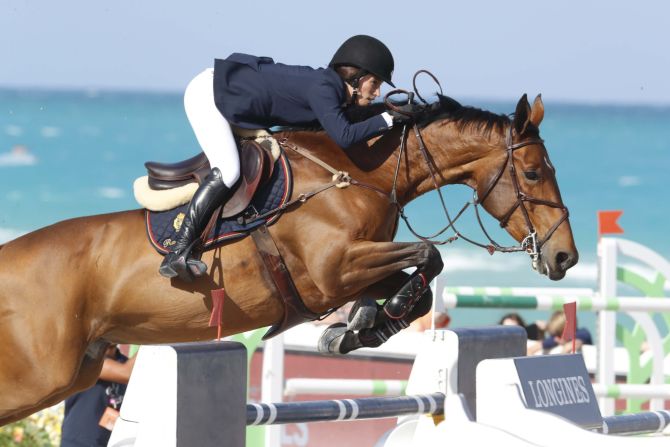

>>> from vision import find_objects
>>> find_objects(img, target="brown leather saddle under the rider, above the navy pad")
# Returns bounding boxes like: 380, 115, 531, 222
144, 140, 275, 217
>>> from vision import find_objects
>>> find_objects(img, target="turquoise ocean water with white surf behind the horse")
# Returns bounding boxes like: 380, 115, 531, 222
0, 89, 670, 328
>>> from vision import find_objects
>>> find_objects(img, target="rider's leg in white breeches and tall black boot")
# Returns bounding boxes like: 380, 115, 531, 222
159, 69, 240, 281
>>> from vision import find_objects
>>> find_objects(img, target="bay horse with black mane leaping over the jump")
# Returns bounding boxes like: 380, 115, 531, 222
0, 95, 578, 425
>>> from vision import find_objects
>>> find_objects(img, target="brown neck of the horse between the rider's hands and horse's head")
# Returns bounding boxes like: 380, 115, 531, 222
398, 122, 504, 204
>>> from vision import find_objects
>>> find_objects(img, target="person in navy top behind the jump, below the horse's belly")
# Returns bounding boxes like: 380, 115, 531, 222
61, 345, 135, 447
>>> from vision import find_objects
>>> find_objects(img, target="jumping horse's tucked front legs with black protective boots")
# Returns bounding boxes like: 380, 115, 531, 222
319, 243, 443, 354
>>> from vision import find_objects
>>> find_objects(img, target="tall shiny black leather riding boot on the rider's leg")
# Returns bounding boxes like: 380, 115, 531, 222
158, 168, 231, 282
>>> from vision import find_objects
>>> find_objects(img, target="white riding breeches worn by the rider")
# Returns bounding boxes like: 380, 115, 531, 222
184, 68, 240, 188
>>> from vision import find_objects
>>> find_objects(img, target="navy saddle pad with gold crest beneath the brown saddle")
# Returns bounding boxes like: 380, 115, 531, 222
145, 153, 293, 254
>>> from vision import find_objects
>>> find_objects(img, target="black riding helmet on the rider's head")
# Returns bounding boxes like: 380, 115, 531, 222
328, 34, 395, 87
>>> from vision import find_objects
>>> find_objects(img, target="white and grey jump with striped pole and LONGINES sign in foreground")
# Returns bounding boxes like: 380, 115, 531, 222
109, 326, 670, 447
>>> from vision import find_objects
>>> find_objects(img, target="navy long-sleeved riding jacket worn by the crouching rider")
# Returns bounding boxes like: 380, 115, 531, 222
214, 53, 388, 148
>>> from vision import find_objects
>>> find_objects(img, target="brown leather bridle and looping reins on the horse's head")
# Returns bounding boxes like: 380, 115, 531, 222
384, 70, 569, 268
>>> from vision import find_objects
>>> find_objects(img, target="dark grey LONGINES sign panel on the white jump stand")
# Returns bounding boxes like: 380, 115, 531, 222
514, 354, 602, 428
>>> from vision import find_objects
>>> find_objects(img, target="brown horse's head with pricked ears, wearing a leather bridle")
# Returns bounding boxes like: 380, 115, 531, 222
473, 94, 579, 280
